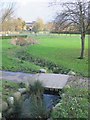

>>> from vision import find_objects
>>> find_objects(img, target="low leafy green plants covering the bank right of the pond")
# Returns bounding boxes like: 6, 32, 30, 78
51, 77, 90, 120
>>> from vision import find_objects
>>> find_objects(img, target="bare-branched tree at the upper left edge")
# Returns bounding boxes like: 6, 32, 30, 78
0, 1, 16, 31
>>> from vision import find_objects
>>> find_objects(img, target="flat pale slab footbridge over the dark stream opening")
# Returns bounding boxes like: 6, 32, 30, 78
35, 73, 69, 90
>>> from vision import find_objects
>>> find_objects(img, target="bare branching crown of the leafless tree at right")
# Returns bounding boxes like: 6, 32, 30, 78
55, 0, 89, 32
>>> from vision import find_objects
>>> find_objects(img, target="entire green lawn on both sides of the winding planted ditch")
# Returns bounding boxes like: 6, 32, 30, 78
0, 34, 88, 76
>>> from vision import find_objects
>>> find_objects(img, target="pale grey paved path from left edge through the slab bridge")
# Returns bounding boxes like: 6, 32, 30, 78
0, 71, 70, 89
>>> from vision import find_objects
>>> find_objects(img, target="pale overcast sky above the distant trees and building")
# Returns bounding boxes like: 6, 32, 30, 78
3, 0, 89, 22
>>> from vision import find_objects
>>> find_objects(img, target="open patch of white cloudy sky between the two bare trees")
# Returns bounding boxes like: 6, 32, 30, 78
17, 1, 55, 22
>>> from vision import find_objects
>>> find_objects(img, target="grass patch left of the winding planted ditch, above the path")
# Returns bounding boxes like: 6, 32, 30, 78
0, 39, 40, 73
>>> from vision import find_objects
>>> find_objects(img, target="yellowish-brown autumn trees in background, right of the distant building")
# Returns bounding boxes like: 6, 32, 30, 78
28, 18, 80, 33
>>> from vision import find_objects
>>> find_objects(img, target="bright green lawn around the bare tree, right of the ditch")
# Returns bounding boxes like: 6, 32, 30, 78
28, 35, 88, 76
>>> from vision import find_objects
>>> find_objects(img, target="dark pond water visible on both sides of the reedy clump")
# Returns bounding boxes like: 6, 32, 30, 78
21, 94, 60, 118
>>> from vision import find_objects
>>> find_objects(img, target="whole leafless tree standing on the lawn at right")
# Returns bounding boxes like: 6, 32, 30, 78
55, 0, 90, 59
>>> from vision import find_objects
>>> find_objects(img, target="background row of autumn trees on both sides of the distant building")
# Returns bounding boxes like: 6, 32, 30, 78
0, 3, 83, 33
